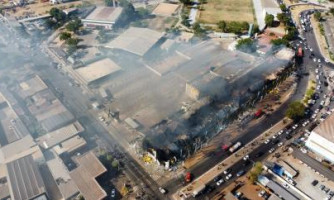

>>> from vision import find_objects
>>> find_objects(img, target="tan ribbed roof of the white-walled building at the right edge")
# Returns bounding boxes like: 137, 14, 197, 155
312, 114, 334, 143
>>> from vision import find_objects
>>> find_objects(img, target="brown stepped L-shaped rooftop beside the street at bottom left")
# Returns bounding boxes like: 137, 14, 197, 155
70, 151, 107, 200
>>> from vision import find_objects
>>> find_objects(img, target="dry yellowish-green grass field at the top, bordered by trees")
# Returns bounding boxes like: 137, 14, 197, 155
197, 0, 255, 24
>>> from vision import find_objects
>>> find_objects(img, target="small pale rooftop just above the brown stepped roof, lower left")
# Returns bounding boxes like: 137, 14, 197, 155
53, 135, 87, 155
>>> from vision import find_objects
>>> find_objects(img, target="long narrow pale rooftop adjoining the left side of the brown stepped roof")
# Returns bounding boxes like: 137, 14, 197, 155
44, 151, 79, 199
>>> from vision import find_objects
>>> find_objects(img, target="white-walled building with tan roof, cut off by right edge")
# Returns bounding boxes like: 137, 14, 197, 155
306, 114, 334, 163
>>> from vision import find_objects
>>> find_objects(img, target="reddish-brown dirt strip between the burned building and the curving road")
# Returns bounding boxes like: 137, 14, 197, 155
184, 77, 294, 168
